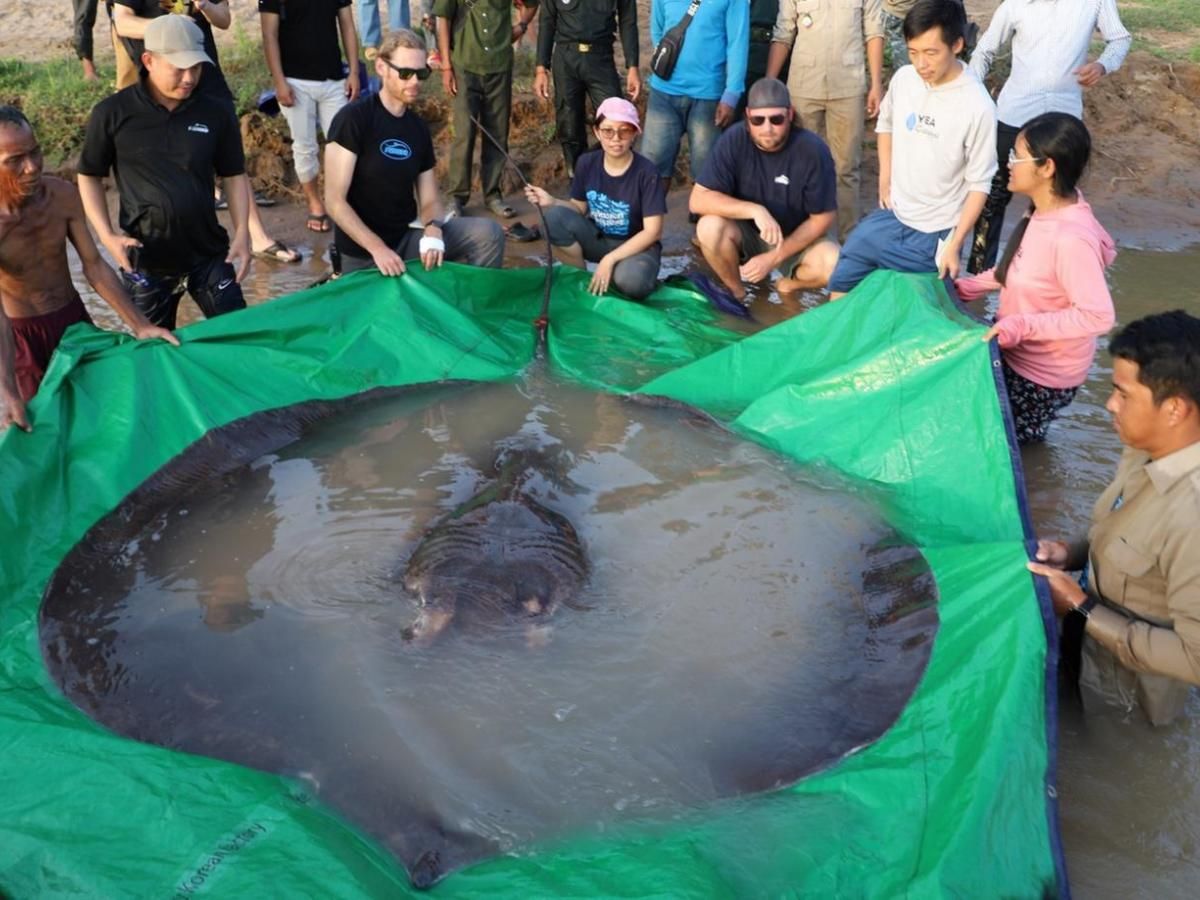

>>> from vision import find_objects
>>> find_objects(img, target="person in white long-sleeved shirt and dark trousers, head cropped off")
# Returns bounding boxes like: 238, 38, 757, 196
967, 0, 1133, 272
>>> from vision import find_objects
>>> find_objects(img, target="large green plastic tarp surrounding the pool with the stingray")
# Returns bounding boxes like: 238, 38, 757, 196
0, 265, 1057, 898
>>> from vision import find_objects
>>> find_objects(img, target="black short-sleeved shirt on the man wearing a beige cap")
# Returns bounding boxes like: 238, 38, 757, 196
79, 74, 246, 275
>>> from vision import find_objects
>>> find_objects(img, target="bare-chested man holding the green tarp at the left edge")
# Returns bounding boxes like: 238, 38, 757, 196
0, 106, 179, 431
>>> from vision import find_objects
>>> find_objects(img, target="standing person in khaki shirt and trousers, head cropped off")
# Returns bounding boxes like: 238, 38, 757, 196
767, 0, 883, 240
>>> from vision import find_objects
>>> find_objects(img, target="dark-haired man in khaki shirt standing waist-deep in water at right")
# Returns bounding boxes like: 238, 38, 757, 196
1030, 311, 1200, 725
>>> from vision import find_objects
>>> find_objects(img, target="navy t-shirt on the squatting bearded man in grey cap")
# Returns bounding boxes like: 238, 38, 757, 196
698, 122, 838, 236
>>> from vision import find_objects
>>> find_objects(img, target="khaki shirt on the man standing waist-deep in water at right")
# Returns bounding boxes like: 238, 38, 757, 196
1082, 443, 1200, 725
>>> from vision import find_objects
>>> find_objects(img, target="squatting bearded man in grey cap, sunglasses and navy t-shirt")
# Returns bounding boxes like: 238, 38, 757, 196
690, 78, 838, 305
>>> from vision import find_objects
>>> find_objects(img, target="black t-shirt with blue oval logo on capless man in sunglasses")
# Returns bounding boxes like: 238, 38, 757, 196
329, 94, 436, 259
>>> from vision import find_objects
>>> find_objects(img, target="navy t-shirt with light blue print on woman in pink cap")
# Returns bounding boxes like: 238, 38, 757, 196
571, 150, 667, 238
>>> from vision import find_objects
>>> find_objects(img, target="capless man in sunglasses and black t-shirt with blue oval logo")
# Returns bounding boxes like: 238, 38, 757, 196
325, 29, 504, 276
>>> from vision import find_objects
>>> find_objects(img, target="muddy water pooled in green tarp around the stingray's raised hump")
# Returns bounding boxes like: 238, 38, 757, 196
43, 374, 936, 876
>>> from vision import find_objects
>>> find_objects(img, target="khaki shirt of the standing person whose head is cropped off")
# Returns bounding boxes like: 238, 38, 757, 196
772, 0, 883, 100
